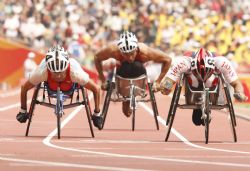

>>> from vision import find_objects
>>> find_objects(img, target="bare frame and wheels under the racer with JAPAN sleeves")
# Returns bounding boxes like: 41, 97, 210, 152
165, 74, 237, 144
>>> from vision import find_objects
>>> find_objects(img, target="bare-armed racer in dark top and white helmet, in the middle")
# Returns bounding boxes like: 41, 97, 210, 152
95, 31, 171, 117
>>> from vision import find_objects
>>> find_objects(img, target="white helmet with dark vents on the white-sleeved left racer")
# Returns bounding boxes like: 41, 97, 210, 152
46, 45, 69, 72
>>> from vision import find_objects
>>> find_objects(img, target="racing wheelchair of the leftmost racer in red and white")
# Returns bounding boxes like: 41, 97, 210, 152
25, 82, 94, 139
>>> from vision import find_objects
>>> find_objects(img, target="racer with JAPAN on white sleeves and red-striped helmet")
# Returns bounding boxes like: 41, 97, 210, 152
160, 48, 247, 126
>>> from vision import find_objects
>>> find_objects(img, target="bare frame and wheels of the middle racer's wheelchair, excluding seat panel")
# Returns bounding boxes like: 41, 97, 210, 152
101, 72, 159, 131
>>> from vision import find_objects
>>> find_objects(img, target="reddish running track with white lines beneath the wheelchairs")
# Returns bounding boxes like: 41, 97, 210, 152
0, 89, 250, 171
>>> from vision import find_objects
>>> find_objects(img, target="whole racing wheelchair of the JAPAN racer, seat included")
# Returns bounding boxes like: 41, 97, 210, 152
165, 74, 237, 144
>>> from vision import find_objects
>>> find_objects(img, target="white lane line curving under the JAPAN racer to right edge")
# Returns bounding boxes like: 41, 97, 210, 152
139, 103, 250, 154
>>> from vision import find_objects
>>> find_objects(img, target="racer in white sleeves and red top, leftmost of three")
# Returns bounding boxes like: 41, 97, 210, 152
16, 45, 100, 129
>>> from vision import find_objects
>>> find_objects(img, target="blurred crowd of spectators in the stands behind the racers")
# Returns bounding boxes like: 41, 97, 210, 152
0, 0, 250, 73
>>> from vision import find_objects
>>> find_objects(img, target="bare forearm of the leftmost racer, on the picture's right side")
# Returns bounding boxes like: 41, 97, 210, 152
84, 80, 100, 112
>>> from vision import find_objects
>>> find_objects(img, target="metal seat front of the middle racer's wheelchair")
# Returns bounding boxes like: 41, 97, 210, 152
115, 74, 147, 97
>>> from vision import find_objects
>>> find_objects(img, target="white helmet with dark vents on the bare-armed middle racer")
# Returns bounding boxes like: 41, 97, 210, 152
117, 31, 138, 53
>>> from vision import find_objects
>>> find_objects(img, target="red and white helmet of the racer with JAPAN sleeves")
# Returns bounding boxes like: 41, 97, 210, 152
191, 48, 215, 81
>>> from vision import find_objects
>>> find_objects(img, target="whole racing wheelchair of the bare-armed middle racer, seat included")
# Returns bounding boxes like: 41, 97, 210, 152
101, 71, 159, 131
